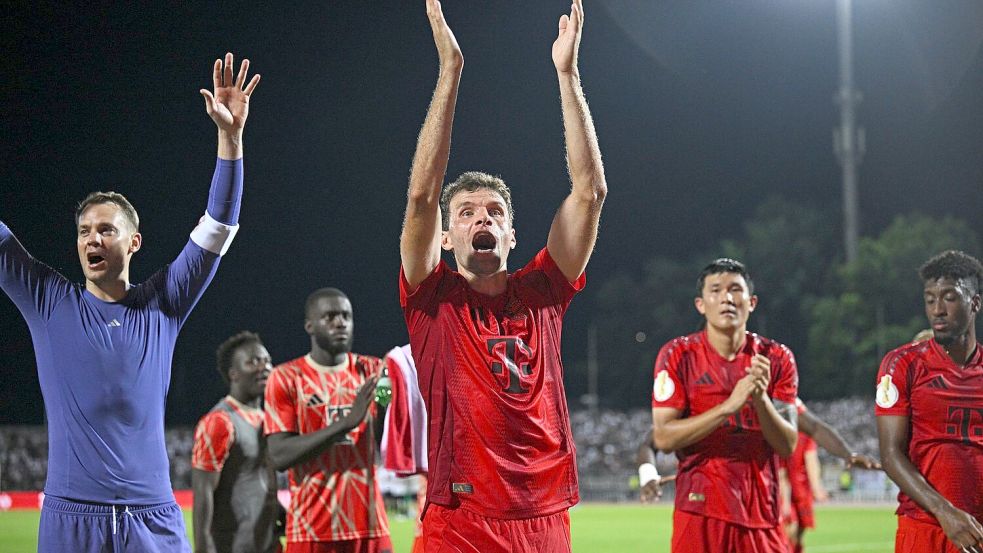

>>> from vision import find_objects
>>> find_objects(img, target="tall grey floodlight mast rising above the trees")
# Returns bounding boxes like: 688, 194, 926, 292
833, 0, 866, 262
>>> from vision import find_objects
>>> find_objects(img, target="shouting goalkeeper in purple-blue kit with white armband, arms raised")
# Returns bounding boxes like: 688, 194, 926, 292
0, 54, 259, 553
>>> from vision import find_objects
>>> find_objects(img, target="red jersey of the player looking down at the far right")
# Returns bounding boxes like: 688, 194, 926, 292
875, 339, 983, 525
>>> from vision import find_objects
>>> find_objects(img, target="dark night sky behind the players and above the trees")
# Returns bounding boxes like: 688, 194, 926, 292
0, 0, 983, 424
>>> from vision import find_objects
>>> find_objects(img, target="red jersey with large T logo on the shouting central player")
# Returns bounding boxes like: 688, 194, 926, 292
400, 248, 585, 519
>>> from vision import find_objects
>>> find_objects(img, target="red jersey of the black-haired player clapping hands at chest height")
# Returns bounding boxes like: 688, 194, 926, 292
652, 331, 799, 528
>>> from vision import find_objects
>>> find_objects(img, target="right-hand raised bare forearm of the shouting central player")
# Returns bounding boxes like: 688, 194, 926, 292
557, 70, 607, 205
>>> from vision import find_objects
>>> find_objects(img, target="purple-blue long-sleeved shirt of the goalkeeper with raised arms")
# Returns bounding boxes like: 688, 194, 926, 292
0, 156, 242, 505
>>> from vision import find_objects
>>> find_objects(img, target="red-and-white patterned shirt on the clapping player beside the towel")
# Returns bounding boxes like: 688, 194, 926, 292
265, 354, 389, 542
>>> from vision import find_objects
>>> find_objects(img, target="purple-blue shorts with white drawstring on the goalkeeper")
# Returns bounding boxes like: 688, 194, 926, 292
38, 495, 191, 553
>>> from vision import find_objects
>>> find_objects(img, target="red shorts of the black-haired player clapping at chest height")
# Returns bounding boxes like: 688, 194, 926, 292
672, 509, 788, 553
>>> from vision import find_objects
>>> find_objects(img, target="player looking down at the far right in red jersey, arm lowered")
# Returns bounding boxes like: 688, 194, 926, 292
875, 250, 983, 553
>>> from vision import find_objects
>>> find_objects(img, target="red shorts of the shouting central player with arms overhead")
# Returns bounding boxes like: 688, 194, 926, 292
423, 503, 570, 553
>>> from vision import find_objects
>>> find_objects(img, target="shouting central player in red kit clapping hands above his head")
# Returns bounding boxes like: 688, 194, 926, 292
400, 0, 607, 553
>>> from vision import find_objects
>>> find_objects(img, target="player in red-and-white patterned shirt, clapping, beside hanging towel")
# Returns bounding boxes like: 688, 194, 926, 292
265, 288, 392, 553
